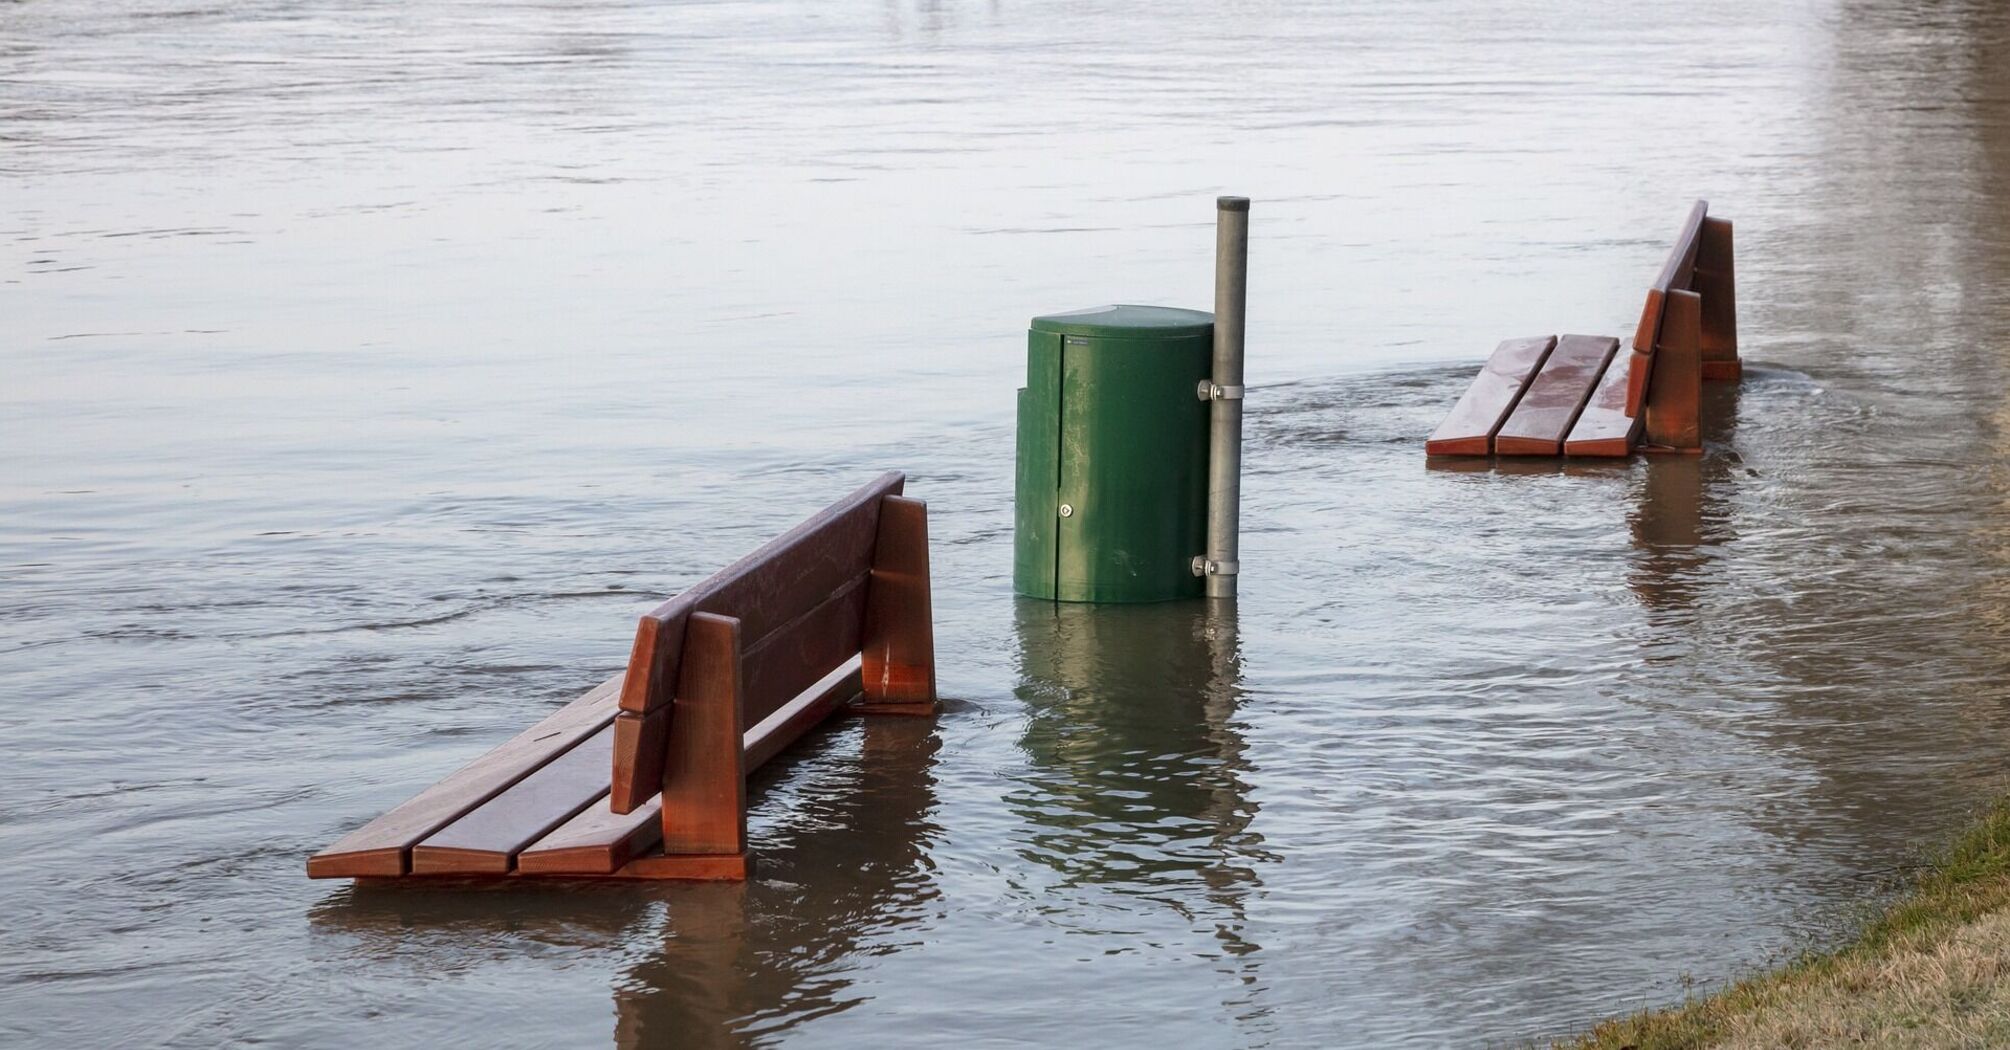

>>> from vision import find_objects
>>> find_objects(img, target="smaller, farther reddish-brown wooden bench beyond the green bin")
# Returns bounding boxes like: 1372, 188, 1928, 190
1425, 201, 1743, 457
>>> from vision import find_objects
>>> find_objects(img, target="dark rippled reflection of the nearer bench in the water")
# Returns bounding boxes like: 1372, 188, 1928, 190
312, 718, 939, 1048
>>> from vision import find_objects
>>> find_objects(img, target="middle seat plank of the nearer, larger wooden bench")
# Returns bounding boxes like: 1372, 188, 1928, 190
412, 726, 615, 875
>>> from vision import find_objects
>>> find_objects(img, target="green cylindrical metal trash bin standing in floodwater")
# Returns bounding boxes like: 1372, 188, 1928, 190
1013, 306, 1214, 601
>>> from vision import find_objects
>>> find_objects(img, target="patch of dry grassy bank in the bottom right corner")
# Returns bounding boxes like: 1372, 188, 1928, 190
1552, 801, 2010, 1050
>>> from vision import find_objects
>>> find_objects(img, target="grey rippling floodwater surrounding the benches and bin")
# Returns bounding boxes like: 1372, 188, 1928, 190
0, 0, 2010, 1048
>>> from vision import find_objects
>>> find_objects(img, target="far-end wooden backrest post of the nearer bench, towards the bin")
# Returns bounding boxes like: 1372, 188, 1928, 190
852, 495, 935, 714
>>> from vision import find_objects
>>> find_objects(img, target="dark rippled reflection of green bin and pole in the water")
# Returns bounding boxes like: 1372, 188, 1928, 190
1007, 599, 1266, 955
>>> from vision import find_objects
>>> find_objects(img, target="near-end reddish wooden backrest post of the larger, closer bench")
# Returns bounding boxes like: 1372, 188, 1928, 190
663, 611, 748, 857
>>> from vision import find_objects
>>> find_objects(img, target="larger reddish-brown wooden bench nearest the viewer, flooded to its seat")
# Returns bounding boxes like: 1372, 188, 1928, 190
308, 473, 935, 879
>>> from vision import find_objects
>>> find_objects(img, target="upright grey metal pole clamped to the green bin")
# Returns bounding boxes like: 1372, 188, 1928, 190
1206, 197, 1250, 597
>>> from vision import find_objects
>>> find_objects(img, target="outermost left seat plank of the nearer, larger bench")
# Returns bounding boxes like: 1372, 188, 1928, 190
308, 674, 623, 879
